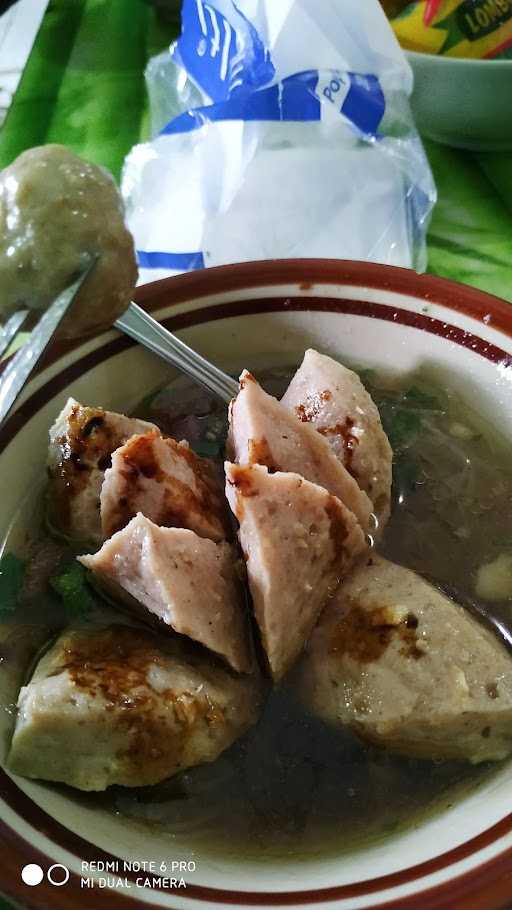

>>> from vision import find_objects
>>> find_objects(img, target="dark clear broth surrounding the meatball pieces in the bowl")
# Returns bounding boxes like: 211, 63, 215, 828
3, 370, 512, 861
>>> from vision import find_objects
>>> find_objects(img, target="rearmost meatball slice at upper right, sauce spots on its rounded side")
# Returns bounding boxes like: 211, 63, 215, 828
281, 349, 393, 530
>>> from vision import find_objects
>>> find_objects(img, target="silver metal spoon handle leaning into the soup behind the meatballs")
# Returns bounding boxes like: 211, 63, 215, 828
114, 303, 238, 404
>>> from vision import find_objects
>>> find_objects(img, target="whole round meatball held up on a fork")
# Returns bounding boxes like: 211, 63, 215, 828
0, 145, 137, 337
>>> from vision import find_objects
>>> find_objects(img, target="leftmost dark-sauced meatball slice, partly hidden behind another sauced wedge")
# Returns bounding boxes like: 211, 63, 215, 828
48, 398, 157, 543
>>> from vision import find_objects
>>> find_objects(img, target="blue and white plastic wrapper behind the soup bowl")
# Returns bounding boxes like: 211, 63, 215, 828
122, 0, 436, 282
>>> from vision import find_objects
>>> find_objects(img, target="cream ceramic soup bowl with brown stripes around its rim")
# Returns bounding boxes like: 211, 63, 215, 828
0, 260, 512, 910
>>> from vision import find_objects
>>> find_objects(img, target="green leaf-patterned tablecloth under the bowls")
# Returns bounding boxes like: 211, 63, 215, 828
0, 0, 512, 907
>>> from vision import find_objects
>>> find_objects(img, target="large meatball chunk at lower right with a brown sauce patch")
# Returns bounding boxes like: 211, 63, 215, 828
298, 555, 512, 763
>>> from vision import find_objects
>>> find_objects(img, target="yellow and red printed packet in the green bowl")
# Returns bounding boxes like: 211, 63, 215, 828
392, 0, 512, 59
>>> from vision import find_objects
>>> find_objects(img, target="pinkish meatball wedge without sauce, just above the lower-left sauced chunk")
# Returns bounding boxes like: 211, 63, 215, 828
79, 514, 252, 672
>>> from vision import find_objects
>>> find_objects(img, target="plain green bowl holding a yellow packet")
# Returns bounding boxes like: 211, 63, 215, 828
406, 51, 512, 151
